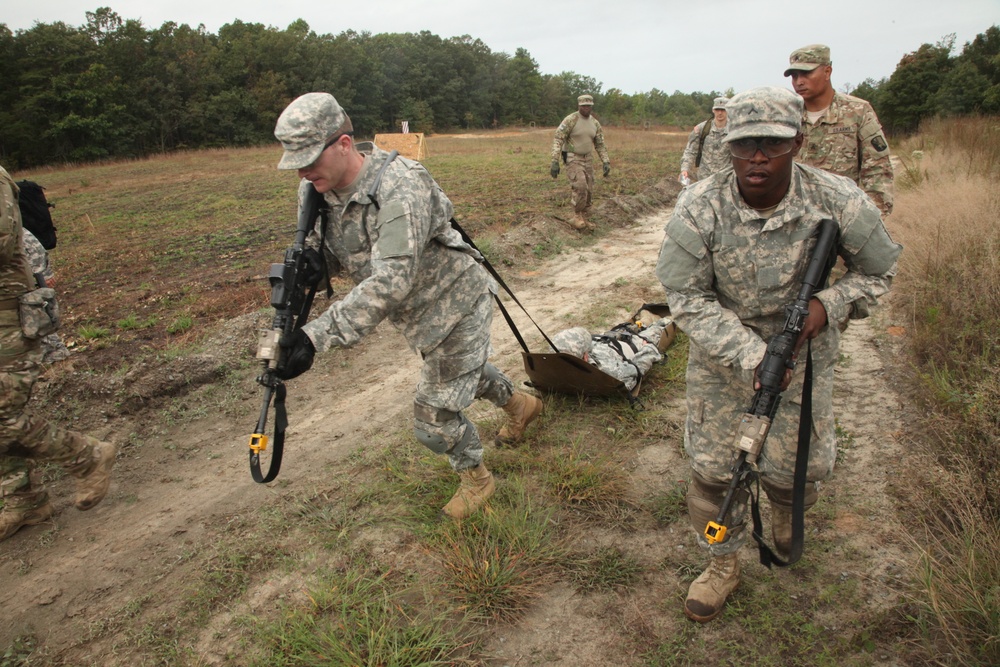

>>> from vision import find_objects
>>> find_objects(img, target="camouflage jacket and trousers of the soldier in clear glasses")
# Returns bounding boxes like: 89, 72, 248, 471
656, 163, 901, 556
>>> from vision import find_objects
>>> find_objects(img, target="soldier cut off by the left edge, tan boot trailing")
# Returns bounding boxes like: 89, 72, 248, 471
0, 167, 115, 539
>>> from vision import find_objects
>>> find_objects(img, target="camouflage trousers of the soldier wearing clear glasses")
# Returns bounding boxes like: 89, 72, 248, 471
684, 336, 839, 556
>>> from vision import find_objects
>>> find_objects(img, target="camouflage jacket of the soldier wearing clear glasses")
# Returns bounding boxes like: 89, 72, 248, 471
656, 164, 902, 371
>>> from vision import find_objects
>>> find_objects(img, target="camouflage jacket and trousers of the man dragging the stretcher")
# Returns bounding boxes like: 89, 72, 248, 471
300, 147, 513, 471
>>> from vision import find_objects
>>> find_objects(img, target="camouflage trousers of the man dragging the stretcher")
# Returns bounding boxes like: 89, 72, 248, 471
413, 292, 514, 472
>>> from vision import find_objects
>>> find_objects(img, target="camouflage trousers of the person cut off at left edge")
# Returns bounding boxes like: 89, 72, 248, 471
0, 318, 89, 506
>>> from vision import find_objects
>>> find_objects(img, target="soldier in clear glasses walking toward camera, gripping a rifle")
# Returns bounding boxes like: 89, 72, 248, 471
656, 88, 901, 622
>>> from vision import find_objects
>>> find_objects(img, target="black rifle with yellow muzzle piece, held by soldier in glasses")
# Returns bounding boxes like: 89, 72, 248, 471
704, 220, 838, 565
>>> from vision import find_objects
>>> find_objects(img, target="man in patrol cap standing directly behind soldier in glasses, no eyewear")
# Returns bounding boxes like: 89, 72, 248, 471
785, 44, 893, 216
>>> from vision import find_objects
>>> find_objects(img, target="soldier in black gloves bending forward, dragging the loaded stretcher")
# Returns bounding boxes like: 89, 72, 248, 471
274, 93, 542, 518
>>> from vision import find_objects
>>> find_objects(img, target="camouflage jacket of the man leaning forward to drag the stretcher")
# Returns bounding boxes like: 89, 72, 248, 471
299, 148, 496, 353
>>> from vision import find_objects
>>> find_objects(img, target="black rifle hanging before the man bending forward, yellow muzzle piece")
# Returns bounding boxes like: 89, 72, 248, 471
250, 184, 326, 484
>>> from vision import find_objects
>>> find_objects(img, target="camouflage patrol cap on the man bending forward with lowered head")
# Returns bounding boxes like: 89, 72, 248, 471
274, 93, 354, 169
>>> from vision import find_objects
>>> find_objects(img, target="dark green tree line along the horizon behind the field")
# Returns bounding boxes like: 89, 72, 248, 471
0, 7, 1000, 169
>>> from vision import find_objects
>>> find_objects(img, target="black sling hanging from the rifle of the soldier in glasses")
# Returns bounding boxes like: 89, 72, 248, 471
748, 341, 813, 568
